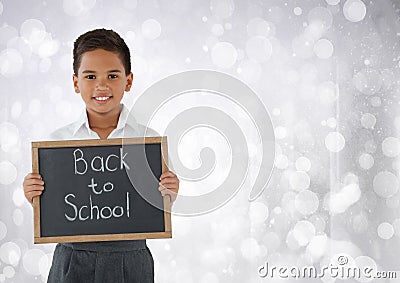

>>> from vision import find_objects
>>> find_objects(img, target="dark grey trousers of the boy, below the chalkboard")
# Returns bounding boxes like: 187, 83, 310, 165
47, 240, 154, 283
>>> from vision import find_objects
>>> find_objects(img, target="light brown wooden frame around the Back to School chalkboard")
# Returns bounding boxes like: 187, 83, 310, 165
32, 136, 172, 244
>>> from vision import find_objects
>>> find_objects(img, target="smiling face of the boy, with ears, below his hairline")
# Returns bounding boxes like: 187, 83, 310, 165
73, 49, 133, 118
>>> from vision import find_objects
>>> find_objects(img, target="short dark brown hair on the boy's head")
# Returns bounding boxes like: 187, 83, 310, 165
73, 29, 131, 75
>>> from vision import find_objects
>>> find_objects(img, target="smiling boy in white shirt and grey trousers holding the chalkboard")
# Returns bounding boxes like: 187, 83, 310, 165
23, 29, 179, 283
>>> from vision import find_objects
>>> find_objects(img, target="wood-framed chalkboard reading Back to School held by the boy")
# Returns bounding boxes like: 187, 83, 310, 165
32, 137, 172, 243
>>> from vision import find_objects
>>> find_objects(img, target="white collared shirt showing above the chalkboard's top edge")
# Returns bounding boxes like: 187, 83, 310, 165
50, 104, 158, 140
